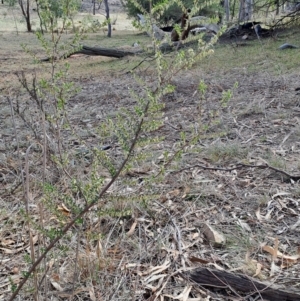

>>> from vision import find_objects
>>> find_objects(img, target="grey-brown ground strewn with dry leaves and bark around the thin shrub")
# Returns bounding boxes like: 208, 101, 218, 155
0, 1, 300, 300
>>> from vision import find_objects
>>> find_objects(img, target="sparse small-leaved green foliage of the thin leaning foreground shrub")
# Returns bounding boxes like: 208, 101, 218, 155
6, 0, 238, 298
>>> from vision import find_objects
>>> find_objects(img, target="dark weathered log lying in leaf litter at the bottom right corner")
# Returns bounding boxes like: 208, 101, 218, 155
184, 268, 300, 301
